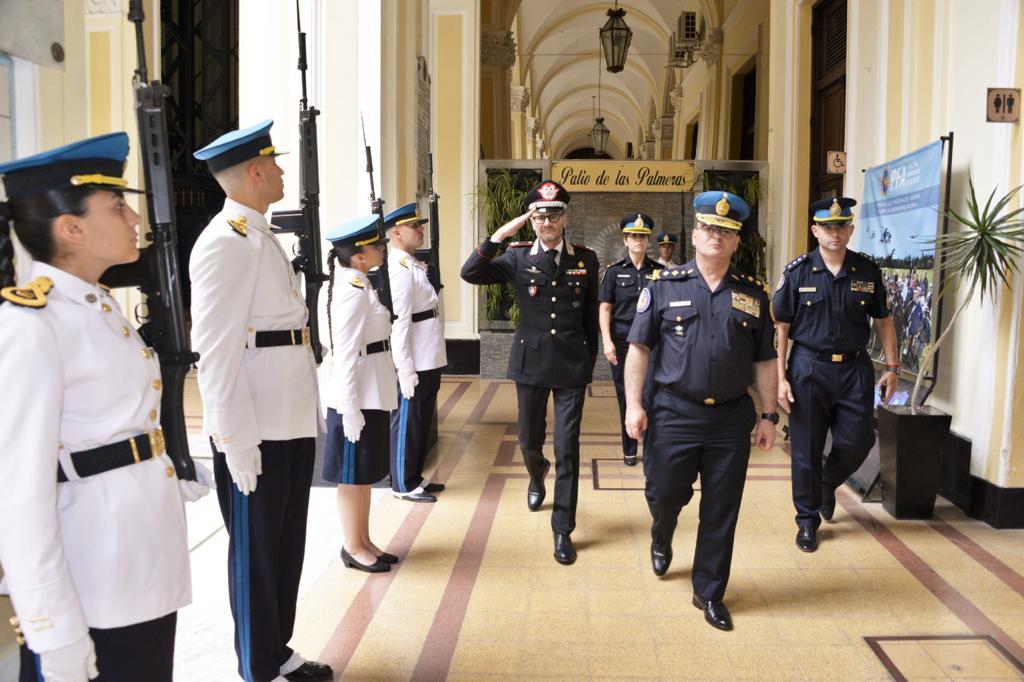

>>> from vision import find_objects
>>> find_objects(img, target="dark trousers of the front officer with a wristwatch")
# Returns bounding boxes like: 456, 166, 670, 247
644, 387, 757, 601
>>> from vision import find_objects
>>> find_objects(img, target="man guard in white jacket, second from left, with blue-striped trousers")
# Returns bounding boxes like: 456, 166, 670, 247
188, 121, 332, 682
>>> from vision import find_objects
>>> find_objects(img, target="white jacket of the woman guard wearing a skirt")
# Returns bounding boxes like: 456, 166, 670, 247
327, 267, 398, 414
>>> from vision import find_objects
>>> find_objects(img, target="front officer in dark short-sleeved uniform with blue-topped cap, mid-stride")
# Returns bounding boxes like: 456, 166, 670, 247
626, 191, 778, 630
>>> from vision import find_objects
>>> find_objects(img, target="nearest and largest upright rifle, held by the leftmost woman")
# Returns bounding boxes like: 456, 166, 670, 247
102, 0, 199, 480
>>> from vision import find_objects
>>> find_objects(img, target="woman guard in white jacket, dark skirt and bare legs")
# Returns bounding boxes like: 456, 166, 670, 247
323, 215, 398, 573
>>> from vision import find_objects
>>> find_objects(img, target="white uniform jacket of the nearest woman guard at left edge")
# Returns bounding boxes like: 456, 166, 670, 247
0, 262, 191, 653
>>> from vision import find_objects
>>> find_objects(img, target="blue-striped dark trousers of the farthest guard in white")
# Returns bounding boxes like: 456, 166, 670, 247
391, 368, 441, 493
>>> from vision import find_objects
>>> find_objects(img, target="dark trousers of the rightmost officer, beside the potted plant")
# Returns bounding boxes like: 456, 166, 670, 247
786, 348, 874, 528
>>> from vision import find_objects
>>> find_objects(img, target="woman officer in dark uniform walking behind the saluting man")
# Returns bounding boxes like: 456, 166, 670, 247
598, 213, 662, 467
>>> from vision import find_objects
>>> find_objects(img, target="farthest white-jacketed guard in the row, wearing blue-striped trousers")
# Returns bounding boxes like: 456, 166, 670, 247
384, 203, 447, 502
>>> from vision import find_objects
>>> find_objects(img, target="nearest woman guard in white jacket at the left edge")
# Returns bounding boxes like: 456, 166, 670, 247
0, 133, 212, 682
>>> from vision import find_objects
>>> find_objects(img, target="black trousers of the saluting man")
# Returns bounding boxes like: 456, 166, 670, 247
515, 383, 587, 534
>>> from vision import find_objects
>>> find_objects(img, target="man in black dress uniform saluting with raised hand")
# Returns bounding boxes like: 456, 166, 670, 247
462, 180, 598, 564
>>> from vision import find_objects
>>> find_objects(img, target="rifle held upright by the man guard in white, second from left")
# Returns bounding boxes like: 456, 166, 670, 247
270, 0, 326, 365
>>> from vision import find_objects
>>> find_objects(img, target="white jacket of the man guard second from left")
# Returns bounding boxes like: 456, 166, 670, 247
188, 199, 323, 452
